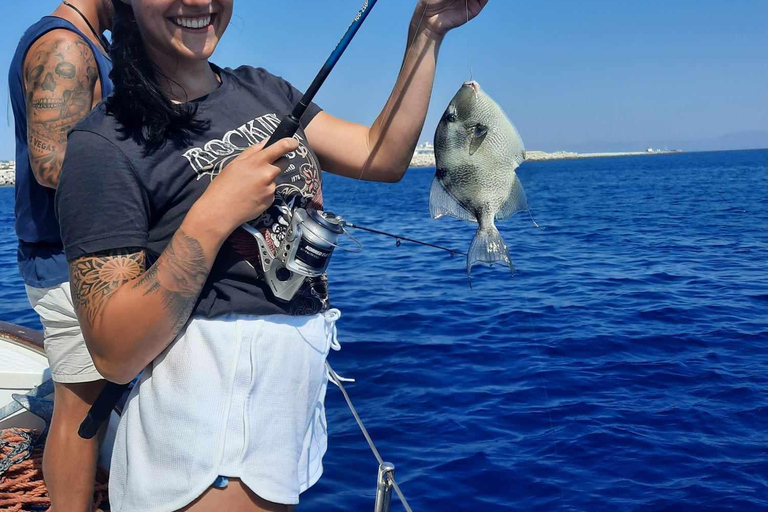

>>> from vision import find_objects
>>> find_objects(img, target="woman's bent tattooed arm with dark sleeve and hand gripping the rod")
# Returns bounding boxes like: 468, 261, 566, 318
61, 131, 298, 382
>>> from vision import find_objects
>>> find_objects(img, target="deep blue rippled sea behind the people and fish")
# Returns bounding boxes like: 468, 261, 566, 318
0, 150, 768, 512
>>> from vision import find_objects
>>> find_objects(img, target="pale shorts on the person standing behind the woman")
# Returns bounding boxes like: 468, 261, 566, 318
26, 282, 104, 384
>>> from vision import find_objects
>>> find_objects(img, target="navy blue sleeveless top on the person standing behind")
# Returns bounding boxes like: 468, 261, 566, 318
8, 16, 112, 288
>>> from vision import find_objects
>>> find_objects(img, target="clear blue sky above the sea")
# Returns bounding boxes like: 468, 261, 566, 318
0, 0, 768, 159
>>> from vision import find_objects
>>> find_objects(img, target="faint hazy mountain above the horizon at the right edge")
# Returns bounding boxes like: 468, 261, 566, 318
553, 130, 768, 153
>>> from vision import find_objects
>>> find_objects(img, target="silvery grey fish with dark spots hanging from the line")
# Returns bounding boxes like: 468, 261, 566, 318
429, 81, 528, 286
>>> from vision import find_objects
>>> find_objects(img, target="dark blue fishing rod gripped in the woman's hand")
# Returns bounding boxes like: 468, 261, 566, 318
77, 0, 378, 439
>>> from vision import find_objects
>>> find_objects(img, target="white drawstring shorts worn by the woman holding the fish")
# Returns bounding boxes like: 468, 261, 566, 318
109, 310, 340, 512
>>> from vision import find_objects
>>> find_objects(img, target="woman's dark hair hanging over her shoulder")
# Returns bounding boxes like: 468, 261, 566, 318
106, 0, 209, 153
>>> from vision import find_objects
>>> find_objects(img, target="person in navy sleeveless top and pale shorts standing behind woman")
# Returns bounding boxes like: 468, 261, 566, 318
8, 0, 113, 512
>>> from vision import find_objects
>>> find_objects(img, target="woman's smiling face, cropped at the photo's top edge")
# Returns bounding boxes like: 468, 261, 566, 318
122, 0, 234, 64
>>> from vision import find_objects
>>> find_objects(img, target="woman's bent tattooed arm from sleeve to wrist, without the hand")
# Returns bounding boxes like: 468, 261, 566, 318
69, 207, 226, 383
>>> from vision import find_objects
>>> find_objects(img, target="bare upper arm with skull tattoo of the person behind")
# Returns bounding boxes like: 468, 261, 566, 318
24, 30, 101, 188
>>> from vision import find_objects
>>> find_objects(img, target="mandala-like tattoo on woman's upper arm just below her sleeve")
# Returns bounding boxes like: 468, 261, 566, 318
69, 249, 146, 325
